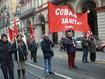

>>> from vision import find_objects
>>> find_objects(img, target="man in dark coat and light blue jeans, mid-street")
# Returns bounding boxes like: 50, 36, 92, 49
41, 35, 54, 74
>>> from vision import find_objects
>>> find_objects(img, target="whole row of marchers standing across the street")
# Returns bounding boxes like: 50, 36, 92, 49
0, 32, 96, 79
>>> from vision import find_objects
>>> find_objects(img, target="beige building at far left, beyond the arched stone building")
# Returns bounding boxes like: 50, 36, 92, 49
0, 0, 16, 35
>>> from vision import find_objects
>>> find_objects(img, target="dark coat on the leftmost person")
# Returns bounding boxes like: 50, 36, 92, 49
0, 41, 13, 63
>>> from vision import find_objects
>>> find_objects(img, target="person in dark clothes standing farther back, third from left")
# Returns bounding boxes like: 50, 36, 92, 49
27, 37, 38, 63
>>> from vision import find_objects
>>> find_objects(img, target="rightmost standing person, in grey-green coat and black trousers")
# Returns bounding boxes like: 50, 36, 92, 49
89, 35, 96, 62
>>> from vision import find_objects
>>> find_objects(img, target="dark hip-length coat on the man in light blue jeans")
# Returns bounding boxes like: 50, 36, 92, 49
41, 40, 54, 58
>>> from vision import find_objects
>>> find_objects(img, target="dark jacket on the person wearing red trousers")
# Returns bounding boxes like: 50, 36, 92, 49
64, 37, 76, 54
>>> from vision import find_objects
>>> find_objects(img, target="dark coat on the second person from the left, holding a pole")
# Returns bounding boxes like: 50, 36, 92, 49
12, 41, 28, 61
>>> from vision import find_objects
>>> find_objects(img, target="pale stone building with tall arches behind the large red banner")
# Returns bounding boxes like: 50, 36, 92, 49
0, 0, 105, 44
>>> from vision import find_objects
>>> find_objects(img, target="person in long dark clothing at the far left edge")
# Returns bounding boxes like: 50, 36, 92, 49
0, 34, 14, 79
